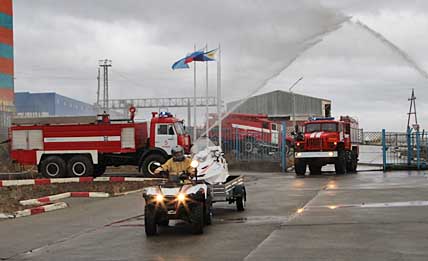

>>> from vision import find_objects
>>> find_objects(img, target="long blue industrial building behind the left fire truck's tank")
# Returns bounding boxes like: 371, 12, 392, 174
15, 92, 96, 117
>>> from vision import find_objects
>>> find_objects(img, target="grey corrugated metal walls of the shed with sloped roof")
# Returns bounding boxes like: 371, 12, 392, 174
227, 91, 330, 116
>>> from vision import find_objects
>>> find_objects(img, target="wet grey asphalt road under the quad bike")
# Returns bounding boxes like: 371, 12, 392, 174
0, 168, 428, 260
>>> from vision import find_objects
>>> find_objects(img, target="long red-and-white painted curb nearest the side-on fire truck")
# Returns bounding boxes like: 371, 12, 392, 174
0, 177, 164, 187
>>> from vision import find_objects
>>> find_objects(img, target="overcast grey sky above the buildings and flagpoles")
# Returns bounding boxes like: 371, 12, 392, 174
14, 0, 428, 130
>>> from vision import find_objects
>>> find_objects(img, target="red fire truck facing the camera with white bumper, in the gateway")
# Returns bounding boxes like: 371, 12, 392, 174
294, 116, 359, 176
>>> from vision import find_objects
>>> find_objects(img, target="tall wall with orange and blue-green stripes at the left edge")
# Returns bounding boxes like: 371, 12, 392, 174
0, 0, 14, 140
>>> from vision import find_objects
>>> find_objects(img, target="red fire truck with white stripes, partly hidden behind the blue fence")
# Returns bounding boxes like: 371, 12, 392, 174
209, 113, 293, 153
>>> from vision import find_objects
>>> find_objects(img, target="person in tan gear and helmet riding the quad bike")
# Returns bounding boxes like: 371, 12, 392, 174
155, 145, 195, 179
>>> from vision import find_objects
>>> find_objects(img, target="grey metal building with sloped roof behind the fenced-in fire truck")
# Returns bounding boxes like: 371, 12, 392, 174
227, 90, 331, 121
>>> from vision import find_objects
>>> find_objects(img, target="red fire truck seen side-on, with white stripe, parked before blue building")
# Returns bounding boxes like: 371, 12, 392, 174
10, 109, 191, 178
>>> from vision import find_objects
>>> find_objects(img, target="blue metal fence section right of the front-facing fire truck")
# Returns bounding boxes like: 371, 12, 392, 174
382, 129, 428, 170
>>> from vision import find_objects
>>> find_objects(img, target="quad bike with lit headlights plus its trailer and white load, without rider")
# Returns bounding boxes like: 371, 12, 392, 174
143, 138, 246, 236
